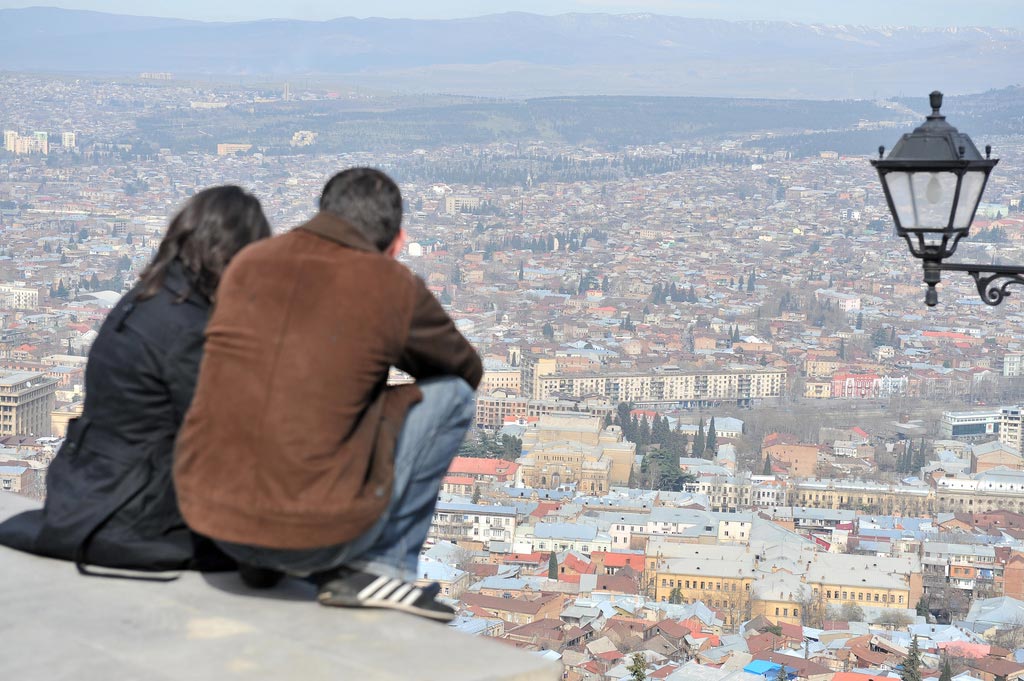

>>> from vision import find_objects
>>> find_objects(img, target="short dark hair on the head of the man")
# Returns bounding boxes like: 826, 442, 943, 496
319, 168, 401, 251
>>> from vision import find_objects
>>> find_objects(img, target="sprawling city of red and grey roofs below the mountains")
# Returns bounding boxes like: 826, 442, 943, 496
0, 5, 1024, 681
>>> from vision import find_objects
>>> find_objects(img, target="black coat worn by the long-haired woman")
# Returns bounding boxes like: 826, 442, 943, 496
0, 262, 230, 571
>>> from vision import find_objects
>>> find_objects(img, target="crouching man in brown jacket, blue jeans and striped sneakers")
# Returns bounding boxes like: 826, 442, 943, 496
174, 168, 482, 620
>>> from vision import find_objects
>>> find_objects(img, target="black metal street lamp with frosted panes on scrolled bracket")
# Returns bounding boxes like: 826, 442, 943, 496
871, 91, 1003, 306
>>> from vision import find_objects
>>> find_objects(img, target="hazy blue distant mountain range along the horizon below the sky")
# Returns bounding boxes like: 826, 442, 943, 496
0, 7, 1024, 98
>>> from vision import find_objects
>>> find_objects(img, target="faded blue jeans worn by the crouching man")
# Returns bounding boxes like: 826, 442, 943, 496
217, 377, 475, 582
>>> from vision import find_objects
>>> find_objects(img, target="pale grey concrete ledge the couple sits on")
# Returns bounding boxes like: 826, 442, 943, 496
0, 493, 561, 681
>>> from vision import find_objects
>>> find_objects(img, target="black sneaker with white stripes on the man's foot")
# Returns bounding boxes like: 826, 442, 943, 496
316, 568, 455, 622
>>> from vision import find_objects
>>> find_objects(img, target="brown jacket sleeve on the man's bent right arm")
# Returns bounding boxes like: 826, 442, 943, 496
395, 276, 483, 390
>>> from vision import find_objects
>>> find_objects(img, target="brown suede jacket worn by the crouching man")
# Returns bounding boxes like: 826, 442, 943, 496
174, 213, 482, 549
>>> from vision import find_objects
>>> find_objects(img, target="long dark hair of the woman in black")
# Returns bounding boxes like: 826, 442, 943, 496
136, 184, 270, 300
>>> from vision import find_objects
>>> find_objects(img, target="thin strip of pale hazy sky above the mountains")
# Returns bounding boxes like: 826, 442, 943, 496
6, 0, 1024, 29
